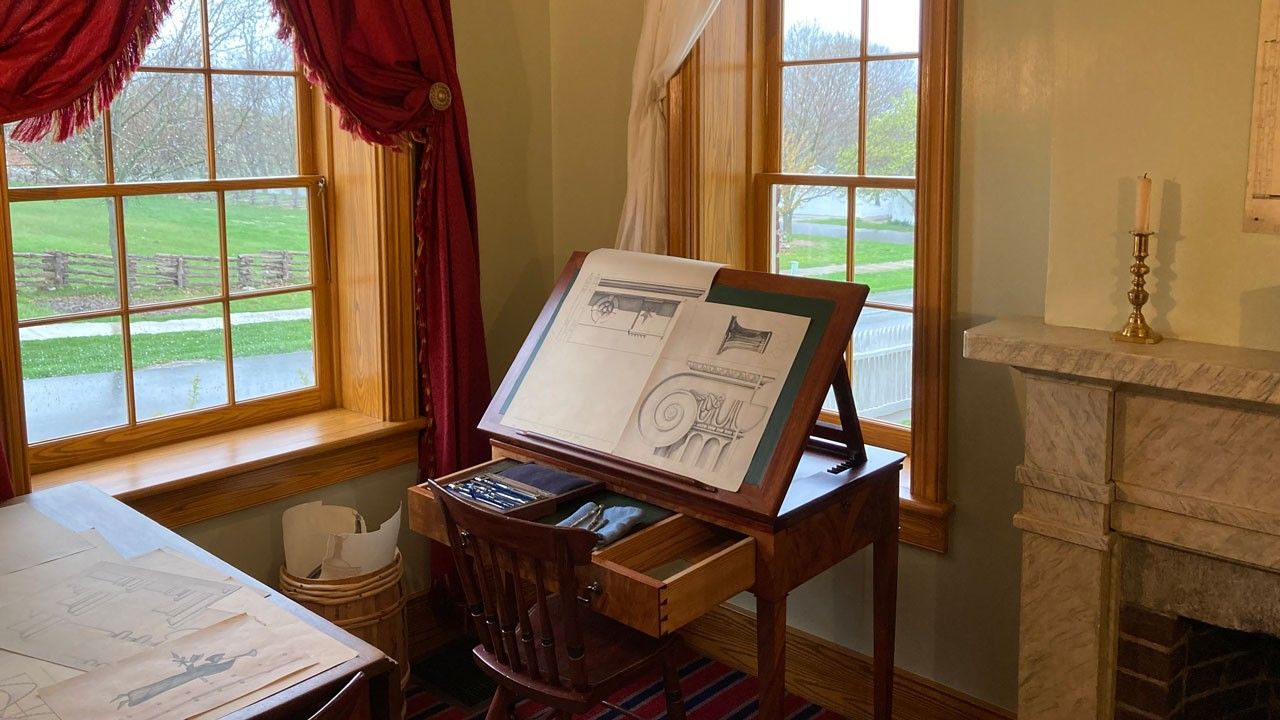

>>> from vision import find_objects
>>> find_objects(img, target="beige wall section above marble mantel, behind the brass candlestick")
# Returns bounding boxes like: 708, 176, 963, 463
1044, 0, 1280, 350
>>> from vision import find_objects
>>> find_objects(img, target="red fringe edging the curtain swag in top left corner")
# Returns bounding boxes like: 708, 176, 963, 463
13, 0, 172, 142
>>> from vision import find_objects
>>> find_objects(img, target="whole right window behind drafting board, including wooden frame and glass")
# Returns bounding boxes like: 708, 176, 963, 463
667, 0, 955, 551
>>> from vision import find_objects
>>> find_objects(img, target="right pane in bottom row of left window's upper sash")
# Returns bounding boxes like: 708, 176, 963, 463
214, 76, 298, 178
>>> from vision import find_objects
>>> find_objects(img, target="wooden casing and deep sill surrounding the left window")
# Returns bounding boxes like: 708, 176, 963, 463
0, 5, 425, 515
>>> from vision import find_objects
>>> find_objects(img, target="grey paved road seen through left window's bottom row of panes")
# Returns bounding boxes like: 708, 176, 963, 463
23, 348, 315, 442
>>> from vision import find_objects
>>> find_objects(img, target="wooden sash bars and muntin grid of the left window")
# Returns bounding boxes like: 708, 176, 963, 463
0, 46, 334, 474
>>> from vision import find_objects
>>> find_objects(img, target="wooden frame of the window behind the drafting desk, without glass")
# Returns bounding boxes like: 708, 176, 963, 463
667, 0, 957, 552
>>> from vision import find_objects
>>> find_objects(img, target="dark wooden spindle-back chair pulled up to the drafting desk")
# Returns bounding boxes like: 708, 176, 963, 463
430, 482, 685, 720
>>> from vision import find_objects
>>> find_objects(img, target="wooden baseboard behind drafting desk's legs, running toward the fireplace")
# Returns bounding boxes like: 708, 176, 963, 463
680, 605, 1015, 720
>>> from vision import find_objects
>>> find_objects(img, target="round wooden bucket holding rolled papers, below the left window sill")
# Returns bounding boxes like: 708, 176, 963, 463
280, 550, 410, 717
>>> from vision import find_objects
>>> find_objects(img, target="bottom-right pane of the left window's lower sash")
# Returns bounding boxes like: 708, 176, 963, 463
232, 292, 316, 401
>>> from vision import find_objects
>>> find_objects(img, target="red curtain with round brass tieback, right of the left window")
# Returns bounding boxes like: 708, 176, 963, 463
273, 0, 489, 477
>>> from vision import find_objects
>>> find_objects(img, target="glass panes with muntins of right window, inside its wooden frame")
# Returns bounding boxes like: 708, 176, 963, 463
762, 0, 920, 438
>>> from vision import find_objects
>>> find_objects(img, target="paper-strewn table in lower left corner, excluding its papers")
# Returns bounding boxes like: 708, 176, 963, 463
5, 483, 402, 720
